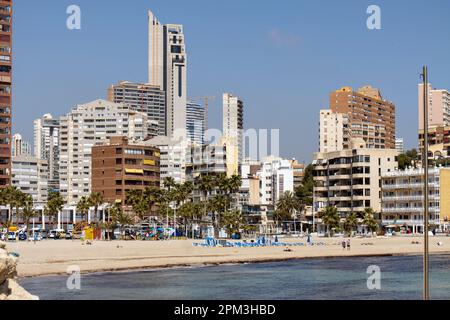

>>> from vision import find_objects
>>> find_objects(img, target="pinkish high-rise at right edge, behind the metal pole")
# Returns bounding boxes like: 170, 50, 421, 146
418, 84, 450, 130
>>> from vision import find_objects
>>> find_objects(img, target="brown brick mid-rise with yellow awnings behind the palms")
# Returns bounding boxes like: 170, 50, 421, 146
92, 137, 160, 205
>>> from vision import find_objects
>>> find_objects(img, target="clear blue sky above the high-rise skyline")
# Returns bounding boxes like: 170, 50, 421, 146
13, 0, 450, 162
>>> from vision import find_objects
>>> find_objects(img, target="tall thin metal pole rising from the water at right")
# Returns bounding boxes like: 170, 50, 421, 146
423, 66, 430, 300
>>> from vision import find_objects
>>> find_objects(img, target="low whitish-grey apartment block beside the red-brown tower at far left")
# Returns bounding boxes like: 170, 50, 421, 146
12, 155, 49, 206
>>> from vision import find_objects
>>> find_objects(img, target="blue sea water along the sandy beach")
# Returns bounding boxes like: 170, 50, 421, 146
20, 255, 450, 300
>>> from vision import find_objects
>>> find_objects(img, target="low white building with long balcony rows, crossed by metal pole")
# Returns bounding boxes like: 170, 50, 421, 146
381, 168, 450, 233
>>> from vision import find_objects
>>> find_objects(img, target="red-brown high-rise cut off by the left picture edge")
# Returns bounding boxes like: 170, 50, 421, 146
0, 0, 13, 188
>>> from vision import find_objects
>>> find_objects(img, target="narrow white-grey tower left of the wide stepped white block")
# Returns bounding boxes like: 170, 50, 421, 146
34, 114, 60, 191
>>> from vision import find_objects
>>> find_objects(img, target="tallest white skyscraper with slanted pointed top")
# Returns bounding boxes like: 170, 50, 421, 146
148, 11, 187, 138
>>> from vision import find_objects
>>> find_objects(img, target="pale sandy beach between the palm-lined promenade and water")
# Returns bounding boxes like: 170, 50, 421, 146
7, 237, 450, 277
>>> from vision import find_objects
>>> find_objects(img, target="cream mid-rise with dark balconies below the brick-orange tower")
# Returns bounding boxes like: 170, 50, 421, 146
313, 139, 398, 218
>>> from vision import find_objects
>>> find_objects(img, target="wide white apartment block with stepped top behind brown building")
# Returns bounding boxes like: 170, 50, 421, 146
60, 100, 155, 205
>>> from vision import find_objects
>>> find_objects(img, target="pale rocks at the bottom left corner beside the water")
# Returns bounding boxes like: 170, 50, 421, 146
0, 242, 39, 300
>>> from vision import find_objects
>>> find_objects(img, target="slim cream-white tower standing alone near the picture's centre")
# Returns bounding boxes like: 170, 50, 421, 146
223, 93, 244, 175
